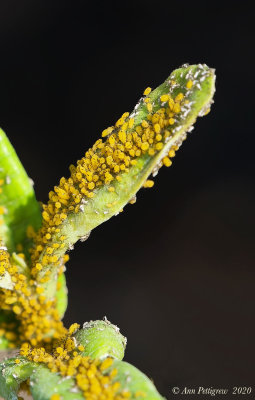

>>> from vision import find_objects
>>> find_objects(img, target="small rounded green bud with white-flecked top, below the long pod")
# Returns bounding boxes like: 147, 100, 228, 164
75, 318, 127, 360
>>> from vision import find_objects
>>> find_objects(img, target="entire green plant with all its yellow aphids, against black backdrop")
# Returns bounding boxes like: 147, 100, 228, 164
0, 64, 215, 400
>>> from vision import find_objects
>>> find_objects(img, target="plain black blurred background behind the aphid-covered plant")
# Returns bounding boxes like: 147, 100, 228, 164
0, 0, 255, 398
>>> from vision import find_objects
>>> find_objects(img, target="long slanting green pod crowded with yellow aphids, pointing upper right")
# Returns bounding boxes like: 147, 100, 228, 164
34, 64, 215, 297
